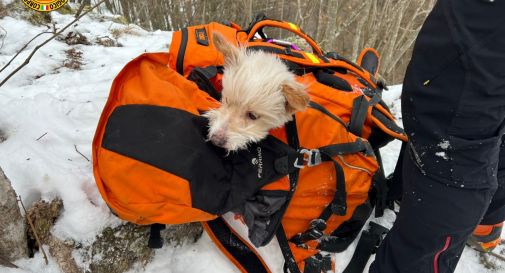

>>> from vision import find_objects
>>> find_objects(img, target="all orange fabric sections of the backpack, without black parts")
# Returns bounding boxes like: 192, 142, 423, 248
93, 20, 407, 272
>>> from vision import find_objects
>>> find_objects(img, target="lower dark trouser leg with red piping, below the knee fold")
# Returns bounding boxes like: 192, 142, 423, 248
370, 151, 494, 273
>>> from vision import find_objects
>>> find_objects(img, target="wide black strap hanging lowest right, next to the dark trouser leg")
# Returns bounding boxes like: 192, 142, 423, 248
343, 222, 389, 273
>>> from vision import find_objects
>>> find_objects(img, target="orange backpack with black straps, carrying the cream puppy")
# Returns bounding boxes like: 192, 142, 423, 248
93, 16, 407, 273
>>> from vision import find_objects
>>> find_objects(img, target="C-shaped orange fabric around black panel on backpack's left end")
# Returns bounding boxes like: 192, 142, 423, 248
93, 53, 219, 224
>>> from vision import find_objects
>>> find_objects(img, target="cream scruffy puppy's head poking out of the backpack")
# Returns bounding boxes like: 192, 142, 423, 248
205, 33, 309, 151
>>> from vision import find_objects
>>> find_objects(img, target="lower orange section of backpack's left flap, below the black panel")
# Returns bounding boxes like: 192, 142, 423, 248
98, 149, 216, 224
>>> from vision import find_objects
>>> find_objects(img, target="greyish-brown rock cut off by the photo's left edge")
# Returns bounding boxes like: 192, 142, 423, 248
0, 169, 28, 261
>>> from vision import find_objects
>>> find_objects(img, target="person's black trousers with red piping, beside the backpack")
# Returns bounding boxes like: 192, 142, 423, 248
370, 0, 505, 273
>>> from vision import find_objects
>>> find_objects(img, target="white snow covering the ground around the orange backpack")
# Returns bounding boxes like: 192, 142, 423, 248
0, 5, 505, 273
